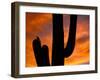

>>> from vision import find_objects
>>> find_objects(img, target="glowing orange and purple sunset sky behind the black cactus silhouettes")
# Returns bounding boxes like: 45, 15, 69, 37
26, 13, 89, 67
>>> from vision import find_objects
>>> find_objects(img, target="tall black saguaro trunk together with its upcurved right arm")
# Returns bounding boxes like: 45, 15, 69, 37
52, 14, 77, 66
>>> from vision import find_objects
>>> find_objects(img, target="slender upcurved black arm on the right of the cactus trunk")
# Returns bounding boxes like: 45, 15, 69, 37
64, 15, 77, 57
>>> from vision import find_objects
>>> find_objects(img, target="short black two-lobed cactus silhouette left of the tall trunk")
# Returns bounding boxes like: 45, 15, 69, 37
33, 37, 50, 66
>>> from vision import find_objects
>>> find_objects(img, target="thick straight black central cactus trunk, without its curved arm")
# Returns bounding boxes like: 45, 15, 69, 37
52, 14, 64, 66
